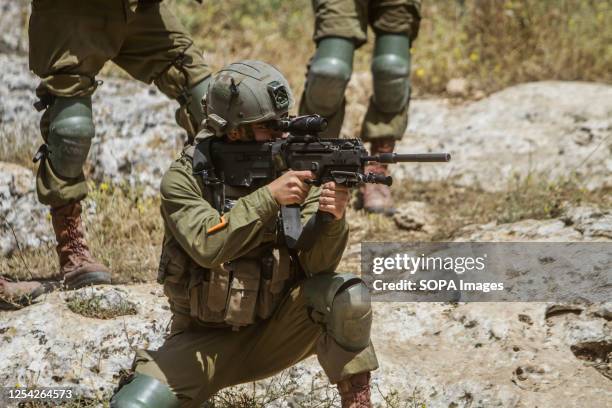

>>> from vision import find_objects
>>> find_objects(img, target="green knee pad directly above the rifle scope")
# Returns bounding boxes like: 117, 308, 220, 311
304, 38, 355, 117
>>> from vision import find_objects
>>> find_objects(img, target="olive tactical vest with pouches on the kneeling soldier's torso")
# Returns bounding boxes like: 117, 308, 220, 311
158, 146, 298, 330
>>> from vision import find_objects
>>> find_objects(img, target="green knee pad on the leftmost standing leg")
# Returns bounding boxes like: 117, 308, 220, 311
47, 96, 95, 178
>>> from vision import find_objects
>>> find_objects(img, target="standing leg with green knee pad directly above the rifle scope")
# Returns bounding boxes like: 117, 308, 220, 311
300, 0, 368, 138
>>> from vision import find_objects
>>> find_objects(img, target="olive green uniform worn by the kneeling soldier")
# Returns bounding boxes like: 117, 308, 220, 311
134, 155, 378, 407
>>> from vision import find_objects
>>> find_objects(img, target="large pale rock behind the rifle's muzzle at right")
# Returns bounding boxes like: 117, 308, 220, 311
391, 81, 612, 191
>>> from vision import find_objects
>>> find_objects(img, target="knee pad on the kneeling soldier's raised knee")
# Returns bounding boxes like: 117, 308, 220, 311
304, 273, 372, 352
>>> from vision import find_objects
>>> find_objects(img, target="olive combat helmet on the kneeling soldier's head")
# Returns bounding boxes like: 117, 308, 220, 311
205, 60, 294, 136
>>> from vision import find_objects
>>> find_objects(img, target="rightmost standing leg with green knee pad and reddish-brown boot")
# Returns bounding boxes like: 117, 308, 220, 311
361, 0, 420, 214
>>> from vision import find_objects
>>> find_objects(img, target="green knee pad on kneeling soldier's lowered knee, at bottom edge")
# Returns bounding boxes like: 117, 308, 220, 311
110, 373, 180, 408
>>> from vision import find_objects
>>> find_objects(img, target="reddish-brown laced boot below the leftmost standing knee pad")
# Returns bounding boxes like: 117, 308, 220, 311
51, 202, 111, 289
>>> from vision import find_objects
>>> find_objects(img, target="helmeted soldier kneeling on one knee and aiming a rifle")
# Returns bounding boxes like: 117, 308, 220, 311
111, 61, 378, 408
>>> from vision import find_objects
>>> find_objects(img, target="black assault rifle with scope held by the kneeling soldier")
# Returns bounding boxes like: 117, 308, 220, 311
193, 115, 450, 249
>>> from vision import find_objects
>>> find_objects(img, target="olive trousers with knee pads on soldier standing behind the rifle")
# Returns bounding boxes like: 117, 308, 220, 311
300, 0, 421, 141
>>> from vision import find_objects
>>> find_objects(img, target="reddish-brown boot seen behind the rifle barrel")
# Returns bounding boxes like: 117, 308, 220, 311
360, 138, 395, 215
